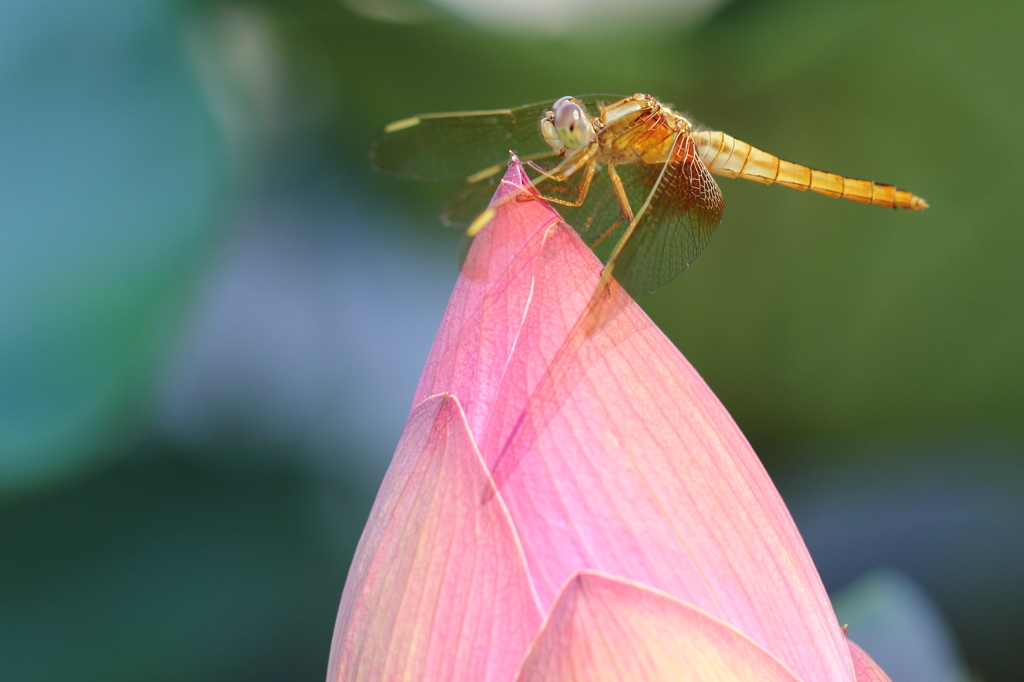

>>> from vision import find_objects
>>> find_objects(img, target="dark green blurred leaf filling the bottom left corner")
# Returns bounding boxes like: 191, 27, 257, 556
0, 443, 372, 682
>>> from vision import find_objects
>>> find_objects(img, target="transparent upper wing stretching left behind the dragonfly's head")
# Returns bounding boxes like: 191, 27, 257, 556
370, 94, 623, 181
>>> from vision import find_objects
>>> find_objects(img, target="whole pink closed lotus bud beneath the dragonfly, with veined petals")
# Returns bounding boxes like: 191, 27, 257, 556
328, 163, 888, 682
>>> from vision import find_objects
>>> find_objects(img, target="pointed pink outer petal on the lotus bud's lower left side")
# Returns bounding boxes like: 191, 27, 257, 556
328, 394, 542, 682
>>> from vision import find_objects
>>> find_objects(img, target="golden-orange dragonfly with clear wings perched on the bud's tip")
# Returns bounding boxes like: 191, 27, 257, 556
371, 93, 928, 299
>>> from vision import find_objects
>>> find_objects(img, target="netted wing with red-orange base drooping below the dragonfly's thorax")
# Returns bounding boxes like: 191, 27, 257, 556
609, 134, 724, 299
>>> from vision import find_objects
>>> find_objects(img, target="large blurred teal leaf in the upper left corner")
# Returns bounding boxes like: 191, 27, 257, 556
0, 0, 226, 491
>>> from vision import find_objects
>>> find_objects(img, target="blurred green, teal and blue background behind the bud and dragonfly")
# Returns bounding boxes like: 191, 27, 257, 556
0, 0, 1024, 682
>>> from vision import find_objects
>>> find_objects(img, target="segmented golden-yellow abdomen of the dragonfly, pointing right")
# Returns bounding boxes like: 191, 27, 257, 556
693, 130, 928, 211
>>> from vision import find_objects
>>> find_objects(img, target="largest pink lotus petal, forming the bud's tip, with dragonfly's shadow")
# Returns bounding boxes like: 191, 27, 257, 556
417, 164, 853, 682
